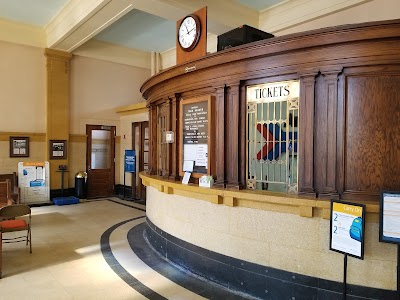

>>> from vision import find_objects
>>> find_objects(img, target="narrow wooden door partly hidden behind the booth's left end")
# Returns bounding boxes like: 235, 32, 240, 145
132, 122, 150, 200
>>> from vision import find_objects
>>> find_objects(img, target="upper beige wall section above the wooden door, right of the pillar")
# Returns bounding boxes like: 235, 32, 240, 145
70, 56, 150, 135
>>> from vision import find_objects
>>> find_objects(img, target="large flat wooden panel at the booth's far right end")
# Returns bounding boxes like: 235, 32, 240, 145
344, 72, 400, 198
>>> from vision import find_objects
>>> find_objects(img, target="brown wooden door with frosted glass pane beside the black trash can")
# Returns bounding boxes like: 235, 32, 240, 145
86, 125, 116, 198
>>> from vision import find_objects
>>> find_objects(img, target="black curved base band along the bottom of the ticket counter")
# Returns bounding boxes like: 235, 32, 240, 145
143, 218, 399, 300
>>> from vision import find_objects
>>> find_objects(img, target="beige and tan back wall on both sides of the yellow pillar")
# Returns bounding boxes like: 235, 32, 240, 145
0, 41, 150, 187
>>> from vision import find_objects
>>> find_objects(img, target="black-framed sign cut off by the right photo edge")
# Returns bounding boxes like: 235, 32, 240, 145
379, 192, 400, 244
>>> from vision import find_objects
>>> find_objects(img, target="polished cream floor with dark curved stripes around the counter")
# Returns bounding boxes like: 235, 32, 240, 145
0, 198, 222, 300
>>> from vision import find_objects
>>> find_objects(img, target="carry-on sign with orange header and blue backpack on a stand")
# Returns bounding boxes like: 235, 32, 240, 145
330, 201, 364, 259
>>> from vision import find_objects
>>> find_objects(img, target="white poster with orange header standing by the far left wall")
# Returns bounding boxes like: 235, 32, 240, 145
18, 161, 50, 204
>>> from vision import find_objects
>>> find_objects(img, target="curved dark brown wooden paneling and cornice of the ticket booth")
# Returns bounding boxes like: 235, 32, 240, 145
141, 20, 400, 200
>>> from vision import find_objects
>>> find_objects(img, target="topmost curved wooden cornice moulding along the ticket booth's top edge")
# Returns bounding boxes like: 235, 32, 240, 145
140, 19, 400, 101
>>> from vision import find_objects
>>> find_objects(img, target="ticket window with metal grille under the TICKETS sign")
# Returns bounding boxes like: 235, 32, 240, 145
246, 80, 300, 193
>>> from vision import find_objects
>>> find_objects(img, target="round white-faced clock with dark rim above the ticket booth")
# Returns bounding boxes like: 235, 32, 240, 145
178, 15, 201, 51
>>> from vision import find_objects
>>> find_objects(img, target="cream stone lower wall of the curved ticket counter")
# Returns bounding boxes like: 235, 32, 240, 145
146, 186, 397, 290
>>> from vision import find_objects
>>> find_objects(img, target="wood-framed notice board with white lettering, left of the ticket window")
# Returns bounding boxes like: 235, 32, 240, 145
179, 95, 213, 178
